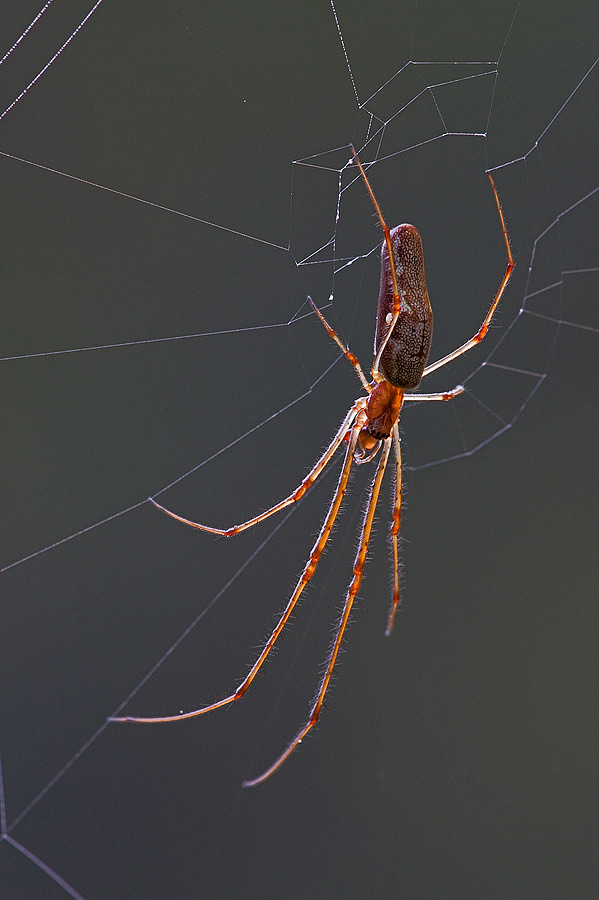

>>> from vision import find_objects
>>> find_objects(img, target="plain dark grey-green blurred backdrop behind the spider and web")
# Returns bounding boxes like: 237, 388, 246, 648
0, 0, 599, 900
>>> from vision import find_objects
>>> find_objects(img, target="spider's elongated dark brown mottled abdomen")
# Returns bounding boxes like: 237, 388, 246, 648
374, 225, 433, 390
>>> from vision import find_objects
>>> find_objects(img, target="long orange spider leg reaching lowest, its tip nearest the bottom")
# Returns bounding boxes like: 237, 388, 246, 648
243, 438, 391, 787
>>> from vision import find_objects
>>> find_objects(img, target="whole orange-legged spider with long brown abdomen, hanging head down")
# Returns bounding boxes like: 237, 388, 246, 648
110, 146, 514, 787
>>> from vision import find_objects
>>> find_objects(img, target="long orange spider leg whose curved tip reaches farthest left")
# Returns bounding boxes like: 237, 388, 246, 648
108, 417, 364, 724
